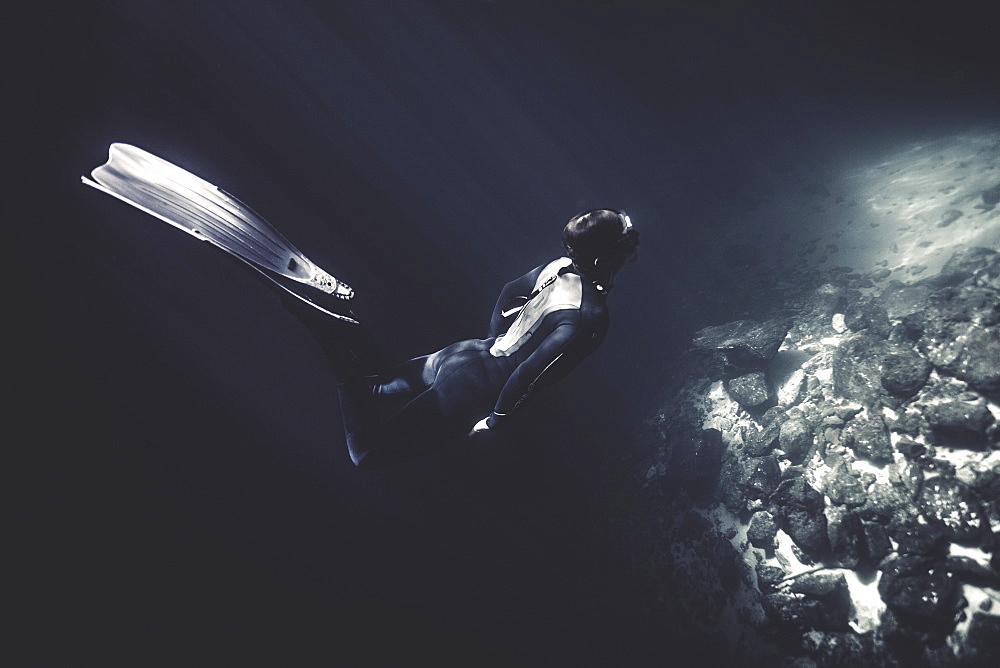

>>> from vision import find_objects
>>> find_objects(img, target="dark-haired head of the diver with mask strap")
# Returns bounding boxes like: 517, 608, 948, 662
562, 209, 639, 280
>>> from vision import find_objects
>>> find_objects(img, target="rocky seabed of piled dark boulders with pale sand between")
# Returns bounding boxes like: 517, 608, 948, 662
643, 248, 1000, 666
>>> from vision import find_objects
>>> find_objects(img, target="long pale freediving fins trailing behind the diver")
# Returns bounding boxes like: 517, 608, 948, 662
81, 143, 357, 322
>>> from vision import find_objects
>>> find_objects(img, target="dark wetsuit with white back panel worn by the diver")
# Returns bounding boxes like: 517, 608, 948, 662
338, 258, 609, 467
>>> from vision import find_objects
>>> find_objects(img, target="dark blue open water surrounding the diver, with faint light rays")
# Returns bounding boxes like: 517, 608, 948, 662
15, 1, 998, 665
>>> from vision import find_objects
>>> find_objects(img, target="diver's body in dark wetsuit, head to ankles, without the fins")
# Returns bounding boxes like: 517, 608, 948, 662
286, 209, 639, 468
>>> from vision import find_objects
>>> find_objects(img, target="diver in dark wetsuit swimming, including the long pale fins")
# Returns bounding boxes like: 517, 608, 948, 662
82, 143, 639, 468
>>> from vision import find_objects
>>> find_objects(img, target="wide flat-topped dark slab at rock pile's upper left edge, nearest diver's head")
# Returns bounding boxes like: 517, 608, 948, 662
692, 320, 790, 377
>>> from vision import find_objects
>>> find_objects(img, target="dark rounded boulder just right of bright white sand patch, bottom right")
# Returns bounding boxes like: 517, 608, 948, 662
878, 555, 960, 634
